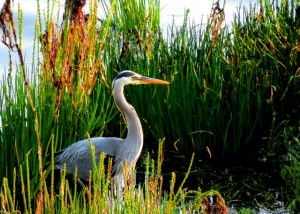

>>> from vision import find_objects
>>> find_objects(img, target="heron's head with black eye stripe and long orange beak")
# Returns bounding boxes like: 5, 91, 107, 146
112, 70, 170, 88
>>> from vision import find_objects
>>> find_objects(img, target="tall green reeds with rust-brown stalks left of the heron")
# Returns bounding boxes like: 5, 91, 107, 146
0, 1, 171, 208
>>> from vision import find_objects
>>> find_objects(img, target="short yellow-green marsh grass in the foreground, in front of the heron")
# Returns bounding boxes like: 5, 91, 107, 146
0, 136, 227, 213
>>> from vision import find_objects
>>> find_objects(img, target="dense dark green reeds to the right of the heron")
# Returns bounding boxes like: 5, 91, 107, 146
119, 1, 299, 156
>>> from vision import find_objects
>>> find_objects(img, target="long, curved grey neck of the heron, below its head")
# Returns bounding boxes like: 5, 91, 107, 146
113, 85, 143, 147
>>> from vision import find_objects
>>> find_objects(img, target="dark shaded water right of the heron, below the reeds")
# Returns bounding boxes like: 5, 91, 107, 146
137, 145, 289, 214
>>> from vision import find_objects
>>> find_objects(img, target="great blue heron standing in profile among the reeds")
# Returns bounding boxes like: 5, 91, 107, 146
54, 70, 169, 186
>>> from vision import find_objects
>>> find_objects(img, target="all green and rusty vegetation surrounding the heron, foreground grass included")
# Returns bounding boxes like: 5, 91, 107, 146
0, 0, 300, 213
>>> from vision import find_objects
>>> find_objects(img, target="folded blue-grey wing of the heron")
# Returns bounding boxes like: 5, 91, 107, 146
54, 137, 123, 180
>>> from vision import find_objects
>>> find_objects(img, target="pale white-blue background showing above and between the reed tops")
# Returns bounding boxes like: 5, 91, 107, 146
0, 0, 258, 69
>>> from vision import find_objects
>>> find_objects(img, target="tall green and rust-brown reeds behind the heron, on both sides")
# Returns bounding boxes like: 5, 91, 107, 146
0, 0, 299, 209
